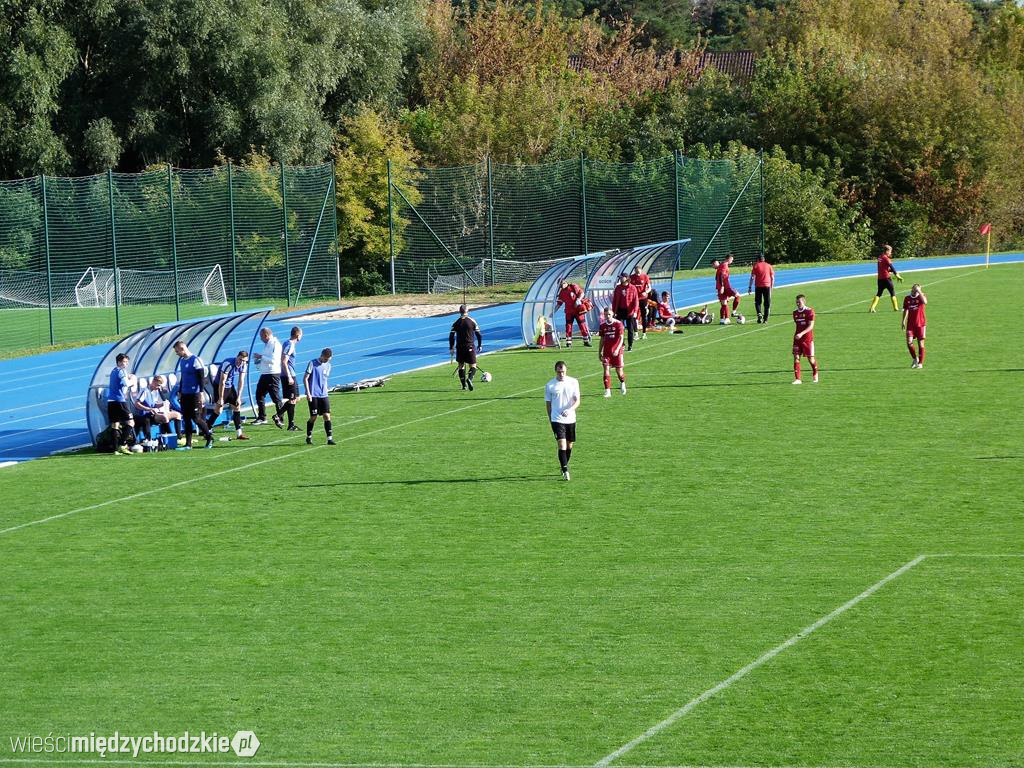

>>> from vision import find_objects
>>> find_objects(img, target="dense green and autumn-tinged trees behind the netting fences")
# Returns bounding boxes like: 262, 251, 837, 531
0, 0, 1024, 280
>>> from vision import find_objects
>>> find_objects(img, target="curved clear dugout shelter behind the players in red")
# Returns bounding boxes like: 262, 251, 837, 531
521, 238, 690, 346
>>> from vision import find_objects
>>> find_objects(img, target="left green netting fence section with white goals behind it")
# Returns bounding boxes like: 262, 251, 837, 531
0, 164, 339, 351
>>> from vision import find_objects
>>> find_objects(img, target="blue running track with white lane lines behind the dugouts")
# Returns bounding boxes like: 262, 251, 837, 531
0, 253, 1024, 467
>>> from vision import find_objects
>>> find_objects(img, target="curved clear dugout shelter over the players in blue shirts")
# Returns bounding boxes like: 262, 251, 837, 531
85, 307, 273, 445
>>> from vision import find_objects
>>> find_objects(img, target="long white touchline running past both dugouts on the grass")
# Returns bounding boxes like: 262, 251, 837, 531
0, 270, 984, 536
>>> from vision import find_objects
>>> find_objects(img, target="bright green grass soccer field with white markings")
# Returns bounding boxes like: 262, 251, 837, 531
0, 265, 1024, 768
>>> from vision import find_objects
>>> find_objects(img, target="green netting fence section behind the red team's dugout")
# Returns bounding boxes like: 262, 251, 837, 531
390, 154, 764, 293
